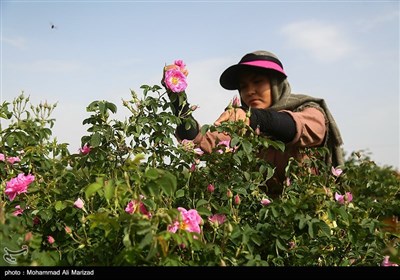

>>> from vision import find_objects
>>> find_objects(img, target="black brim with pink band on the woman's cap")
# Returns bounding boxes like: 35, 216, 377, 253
219, 61, 286, 90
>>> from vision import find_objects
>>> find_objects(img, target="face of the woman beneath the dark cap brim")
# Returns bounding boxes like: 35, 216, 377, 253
239, 71, 272, 109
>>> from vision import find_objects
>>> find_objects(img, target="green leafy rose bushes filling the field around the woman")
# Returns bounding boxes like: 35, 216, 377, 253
0, 90, 400, 266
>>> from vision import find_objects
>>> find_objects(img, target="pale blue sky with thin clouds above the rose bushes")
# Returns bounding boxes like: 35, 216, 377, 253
1, 0, 400, 169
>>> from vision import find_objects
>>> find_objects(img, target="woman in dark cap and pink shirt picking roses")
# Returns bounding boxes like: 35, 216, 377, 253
166, 51, 344, 195
